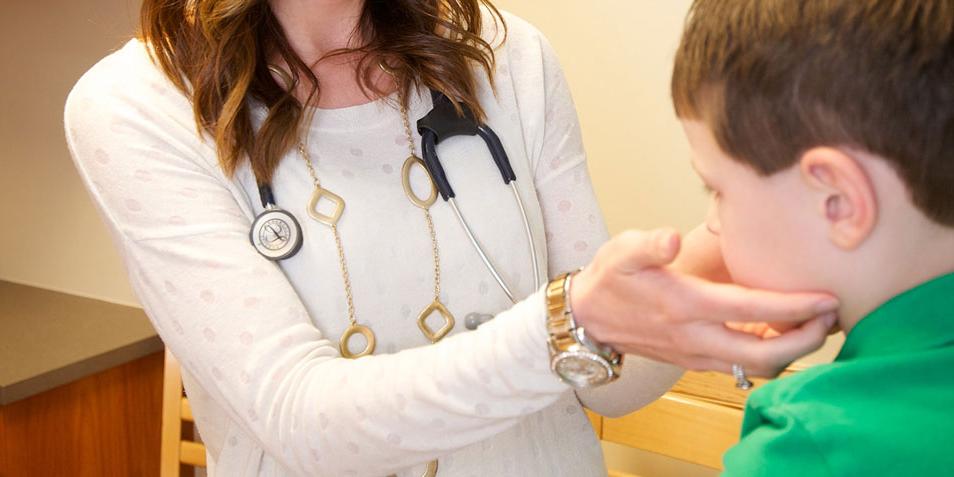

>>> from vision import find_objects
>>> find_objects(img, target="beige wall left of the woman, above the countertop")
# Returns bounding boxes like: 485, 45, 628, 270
0, 0, 139, 304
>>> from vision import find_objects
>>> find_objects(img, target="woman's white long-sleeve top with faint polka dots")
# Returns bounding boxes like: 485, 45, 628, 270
65, 14, 680, 477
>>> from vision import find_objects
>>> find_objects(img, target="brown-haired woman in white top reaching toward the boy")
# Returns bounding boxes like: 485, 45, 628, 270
66, 0, 834, 476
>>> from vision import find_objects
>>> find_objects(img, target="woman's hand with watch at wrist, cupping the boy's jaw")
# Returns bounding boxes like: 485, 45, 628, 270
570, 230, 838, 377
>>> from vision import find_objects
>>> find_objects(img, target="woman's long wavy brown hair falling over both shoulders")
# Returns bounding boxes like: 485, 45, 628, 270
139, 0, 506, 183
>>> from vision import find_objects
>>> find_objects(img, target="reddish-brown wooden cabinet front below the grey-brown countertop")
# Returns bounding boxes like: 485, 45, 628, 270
0, 353, 163, 477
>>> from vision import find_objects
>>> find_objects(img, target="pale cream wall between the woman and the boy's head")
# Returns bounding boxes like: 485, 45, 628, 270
496, 0, 706, 232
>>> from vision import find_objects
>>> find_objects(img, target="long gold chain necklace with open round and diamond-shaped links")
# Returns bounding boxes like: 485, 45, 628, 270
298, 96, 456, 359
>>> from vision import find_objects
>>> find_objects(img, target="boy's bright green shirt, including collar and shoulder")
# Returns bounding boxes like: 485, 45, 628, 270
722, 273, 954, 477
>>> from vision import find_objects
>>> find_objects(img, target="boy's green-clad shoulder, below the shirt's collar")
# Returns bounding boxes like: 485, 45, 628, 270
724, 346, 954, 477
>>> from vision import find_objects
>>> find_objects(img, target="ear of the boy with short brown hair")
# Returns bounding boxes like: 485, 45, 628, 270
799, 147, 878, 250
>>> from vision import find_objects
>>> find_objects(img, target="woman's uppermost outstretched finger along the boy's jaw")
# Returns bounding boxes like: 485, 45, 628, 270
678, 276, 839, 323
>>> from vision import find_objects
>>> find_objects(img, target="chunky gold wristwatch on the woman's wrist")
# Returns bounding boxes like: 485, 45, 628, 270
546, 270, 623, 389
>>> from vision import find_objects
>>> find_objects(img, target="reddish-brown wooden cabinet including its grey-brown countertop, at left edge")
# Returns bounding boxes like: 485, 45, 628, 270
0, 281, 163, 477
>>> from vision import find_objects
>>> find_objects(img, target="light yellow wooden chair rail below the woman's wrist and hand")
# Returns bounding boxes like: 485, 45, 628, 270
603, 393, 742, 469
